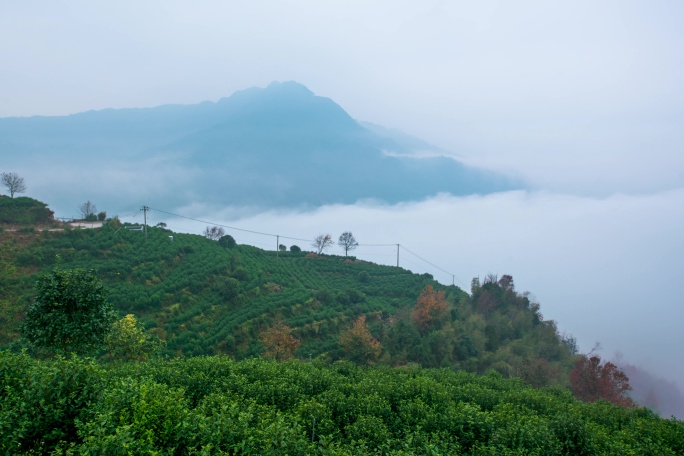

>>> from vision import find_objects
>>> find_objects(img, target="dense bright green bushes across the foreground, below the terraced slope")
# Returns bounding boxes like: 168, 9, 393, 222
0, 352, 684, 455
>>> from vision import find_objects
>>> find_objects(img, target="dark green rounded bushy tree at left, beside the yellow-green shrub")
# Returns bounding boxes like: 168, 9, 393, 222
21, 265, 116, 354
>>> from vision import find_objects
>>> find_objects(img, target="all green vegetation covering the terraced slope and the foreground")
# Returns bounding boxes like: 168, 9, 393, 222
0, 198, 684, 455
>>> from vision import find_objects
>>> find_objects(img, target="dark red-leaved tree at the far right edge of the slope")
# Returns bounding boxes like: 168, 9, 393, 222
570, 355, 633, 407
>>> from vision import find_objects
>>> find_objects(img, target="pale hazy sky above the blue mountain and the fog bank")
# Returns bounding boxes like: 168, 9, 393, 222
5, 0, 684, 195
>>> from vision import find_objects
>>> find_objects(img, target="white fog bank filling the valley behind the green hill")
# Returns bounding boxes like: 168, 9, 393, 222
143, 189, 684, 394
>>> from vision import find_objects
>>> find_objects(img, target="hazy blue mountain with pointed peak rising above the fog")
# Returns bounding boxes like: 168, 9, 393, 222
0, 82, 522, 213
